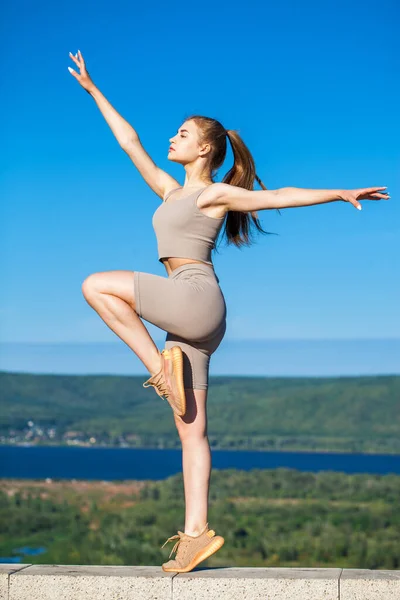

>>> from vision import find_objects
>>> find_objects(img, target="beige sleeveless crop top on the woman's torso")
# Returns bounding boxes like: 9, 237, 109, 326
152, 186, 225, 265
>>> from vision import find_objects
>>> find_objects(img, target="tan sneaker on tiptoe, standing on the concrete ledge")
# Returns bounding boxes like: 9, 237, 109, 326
161, 523, 225, 573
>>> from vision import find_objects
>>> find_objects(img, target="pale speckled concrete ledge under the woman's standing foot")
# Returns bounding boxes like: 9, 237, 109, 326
0, 564, 400, 600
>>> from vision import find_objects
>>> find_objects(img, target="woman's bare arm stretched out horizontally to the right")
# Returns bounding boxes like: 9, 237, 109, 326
218, 183, 390, 212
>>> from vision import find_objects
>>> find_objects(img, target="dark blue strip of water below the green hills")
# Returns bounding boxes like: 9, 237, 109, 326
0, 446, 400, 481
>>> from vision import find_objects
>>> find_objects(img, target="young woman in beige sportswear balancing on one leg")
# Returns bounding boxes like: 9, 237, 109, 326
68, 51, 389, 572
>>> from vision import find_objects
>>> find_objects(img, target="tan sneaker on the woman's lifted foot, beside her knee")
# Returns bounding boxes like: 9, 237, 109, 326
143, 346, 186, 417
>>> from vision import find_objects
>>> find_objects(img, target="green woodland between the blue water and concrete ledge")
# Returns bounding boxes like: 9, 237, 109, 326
0, 468, 400, 569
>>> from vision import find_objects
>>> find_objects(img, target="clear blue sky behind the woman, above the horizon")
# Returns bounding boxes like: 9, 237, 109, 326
0, 0, 400, 376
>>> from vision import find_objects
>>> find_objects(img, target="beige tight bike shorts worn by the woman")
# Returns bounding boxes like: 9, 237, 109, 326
134, 263, 227, 390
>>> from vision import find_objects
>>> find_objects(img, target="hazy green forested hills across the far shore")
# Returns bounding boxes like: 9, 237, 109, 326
0, 372, 400, 453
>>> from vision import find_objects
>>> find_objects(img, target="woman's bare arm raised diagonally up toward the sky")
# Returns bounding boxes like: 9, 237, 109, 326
68, 50, 179, 198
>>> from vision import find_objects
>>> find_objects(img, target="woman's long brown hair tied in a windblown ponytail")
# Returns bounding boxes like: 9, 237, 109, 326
185, 115, 281, 254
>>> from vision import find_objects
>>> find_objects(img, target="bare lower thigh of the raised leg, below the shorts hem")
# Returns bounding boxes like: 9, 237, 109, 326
82, 270, 136, 310
